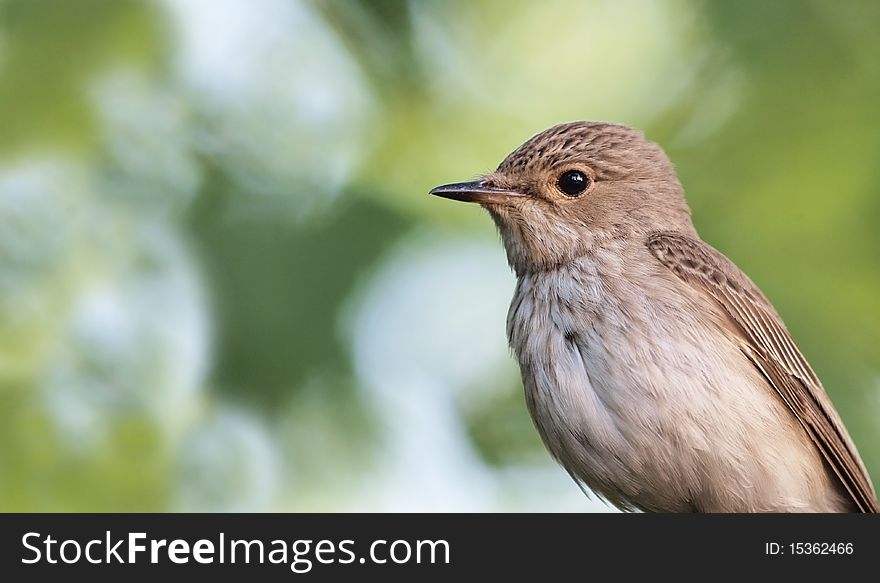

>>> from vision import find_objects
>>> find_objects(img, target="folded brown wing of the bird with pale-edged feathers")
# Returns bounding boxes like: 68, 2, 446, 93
647, 233, 880, 512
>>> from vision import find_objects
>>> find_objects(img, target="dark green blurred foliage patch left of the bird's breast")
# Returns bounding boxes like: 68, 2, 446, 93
190, 176, 403, 407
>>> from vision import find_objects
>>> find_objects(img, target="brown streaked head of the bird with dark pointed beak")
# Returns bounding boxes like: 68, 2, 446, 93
431, 122, 693, 273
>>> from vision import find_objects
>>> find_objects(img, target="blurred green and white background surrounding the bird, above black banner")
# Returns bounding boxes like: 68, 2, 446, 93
0, 0, 880, 511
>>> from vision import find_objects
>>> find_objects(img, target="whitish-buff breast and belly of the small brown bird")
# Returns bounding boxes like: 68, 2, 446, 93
508, 241, 840, 511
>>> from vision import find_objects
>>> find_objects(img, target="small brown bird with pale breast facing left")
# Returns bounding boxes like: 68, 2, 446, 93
430, 121, 880, 513
